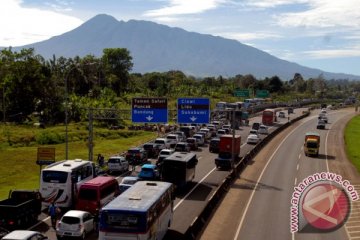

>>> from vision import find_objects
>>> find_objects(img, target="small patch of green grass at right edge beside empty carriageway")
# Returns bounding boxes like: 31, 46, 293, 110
345, 115, 360, 172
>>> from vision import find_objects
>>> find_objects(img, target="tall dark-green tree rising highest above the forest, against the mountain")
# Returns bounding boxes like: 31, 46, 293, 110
102, 48, 133, 96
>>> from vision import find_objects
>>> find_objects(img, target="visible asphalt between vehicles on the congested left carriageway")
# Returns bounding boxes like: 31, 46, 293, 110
27, 109, 304, 240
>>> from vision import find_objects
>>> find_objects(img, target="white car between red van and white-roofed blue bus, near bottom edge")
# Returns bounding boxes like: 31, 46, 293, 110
56, 210, 95, 239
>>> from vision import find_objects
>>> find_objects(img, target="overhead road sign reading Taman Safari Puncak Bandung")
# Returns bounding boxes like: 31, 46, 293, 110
131, 98, 168, 123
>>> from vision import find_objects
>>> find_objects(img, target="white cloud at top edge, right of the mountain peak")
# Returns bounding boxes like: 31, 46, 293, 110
144, 0, 226, 17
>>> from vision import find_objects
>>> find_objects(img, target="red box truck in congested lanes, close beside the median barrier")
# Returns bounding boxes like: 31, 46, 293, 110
215, 134, 241, 168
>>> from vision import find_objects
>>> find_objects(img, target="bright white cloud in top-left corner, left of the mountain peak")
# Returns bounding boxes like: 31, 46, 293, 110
0, 0, 82, 47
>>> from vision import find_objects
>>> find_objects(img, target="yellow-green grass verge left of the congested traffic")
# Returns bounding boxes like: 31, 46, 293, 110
0, 124, 157, 199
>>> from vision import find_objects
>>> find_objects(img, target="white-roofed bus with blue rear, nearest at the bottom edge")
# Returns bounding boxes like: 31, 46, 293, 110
99, 181, 174, 240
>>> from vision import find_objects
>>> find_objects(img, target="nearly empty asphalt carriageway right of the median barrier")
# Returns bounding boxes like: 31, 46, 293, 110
200, 110, 358, 240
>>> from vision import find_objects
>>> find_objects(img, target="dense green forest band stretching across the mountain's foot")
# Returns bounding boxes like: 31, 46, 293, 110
0, 48, 360, 124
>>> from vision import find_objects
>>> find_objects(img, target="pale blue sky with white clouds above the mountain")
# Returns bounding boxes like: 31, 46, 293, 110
0, 0, 360, 76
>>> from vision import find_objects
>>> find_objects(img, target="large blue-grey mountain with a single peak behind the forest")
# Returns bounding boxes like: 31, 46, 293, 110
8, 14, 360, 80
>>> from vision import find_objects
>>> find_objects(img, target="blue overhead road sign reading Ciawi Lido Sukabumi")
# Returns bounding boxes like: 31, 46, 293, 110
177, 98, 210, 124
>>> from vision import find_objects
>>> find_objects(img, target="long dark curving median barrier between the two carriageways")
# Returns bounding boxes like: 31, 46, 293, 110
184, 111, 310, 239
